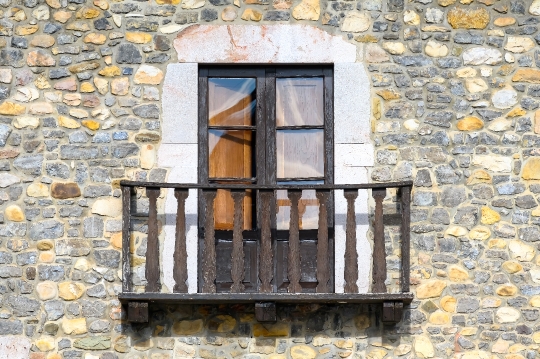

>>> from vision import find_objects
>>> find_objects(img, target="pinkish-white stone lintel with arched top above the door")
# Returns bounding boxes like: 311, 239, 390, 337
174, 24, 356, 63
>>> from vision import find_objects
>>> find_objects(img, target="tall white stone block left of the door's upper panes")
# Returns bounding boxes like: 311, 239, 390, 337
165, 64, 199, 143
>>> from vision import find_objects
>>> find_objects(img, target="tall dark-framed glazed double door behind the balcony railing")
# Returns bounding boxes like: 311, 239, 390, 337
199, 66, 334, 292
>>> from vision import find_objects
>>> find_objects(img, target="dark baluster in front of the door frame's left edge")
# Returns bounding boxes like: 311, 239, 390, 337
202, 190, 216, 293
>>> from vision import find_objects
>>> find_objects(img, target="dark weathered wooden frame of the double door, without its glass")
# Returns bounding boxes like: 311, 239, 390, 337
197, 64, 335, 292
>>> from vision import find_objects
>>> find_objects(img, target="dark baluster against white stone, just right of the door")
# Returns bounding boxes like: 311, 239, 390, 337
343, 190, 358, 293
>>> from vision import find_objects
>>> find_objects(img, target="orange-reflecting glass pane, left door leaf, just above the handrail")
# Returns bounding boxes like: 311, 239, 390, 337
208, 130, 255, 178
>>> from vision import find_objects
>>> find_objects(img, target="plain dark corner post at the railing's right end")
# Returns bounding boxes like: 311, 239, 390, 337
401, 186, 411, 292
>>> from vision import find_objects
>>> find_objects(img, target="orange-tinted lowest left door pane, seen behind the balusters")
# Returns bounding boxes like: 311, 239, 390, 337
214, 189, 254, 230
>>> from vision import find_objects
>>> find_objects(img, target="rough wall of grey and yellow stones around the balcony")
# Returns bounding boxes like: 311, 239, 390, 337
0, 0, 540, 359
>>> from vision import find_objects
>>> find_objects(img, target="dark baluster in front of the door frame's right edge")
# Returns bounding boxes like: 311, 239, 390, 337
316, 191, 330, 293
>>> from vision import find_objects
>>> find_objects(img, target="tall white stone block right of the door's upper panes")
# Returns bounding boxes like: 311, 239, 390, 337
334, 63, 371, 144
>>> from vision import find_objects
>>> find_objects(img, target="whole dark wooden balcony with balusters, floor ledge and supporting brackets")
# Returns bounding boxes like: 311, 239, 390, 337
119, 181, 413, 322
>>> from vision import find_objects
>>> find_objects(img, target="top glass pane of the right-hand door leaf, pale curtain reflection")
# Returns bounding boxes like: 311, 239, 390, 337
276, 77, 324, 126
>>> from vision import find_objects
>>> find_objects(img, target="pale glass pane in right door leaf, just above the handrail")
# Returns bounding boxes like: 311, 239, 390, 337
276, 130, 324, 178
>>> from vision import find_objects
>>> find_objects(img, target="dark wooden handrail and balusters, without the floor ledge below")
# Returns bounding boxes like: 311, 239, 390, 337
120, 180, 413, 297
